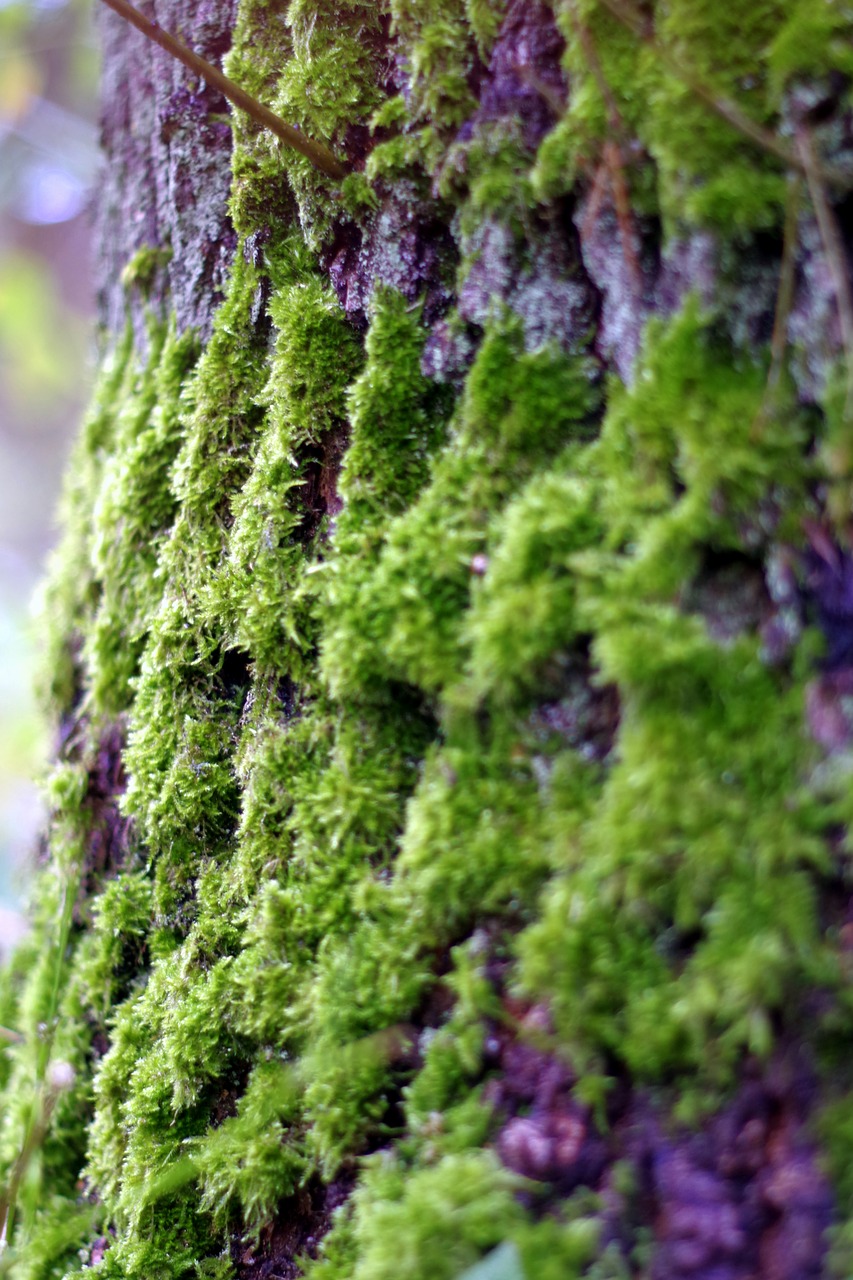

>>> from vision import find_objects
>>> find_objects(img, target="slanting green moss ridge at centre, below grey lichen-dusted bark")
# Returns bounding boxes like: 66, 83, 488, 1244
322, 320, 596, 692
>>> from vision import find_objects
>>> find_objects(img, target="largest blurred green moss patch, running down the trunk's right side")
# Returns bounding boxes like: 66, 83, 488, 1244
521, 307, 819, 1078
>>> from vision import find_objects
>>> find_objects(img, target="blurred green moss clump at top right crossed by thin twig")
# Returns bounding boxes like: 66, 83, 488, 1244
534, 0, 795, 237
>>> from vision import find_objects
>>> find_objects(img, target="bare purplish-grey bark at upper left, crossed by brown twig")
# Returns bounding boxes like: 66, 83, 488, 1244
95, 0, 236, 346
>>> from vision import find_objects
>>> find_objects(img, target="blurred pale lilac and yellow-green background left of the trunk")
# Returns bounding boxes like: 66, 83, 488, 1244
0, 0, 97, 954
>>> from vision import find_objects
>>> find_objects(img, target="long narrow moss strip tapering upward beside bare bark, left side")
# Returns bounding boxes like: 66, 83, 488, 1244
124, 254, 264, 925
